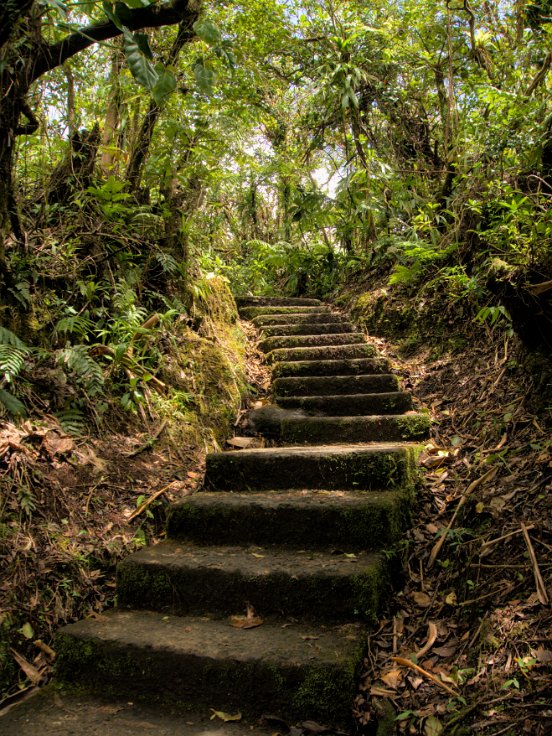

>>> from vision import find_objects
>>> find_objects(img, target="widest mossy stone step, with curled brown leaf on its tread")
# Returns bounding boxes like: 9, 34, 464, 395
55, 610, 364, 726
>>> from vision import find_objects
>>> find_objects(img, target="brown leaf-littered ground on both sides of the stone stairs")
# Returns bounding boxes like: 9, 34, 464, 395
0, 306, 552, 736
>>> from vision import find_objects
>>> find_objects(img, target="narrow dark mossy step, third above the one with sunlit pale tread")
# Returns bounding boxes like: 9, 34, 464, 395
272, 373, 399, 396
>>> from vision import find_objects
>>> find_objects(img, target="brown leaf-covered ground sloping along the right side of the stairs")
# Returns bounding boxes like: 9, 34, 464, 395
356, 333, 552, 736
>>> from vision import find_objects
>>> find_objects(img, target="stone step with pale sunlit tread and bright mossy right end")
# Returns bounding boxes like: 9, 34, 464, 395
205, 443, 414, 491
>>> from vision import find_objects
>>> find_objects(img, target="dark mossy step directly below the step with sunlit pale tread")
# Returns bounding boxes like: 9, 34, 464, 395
167, 490, 409, 552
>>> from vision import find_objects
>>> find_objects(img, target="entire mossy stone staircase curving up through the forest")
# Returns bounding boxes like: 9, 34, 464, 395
57, 298, 428, 726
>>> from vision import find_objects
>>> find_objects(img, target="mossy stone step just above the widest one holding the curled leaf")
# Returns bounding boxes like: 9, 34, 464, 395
117, 539, 387, 622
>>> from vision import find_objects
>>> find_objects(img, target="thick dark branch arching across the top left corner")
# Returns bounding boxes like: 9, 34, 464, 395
28, 0, 200, 84
